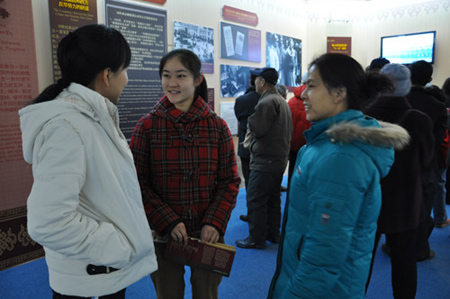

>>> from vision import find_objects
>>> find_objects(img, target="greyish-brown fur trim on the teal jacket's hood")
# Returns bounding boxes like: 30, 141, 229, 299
325, 121, 411, 150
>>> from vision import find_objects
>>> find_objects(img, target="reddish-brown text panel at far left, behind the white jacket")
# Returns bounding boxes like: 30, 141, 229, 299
0, 1, 44, 272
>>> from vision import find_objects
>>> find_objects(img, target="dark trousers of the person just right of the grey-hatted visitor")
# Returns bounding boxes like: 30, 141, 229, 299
417, 170, 436, 260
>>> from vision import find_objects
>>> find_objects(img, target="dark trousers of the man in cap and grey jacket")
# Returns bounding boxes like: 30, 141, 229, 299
247, 170, 283, 243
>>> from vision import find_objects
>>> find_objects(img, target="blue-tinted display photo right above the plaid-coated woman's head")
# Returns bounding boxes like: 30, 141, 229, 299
173, 21, 214, 74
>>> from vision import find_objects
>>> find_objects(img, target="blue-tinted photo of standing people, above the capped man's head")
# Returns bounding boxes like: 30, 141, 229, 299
266, 32, 302, 87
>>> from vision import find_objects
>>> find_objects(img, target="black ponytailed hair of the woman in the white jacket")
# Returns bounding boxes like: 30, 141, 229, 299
31, 24, 131, 104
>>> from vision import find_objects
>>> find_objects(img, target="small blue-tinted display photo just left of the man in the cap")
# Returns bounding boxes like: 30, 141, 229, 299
220, 64, 255, 98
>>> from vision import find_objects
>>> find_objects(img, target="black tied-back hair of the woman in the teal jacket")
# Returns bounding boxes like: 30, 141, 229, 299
310, 53, 394, 110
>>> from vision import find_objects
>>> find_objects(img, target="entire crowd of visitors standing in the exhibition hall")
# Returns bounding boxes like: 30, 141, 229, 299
19, 25, 450, 299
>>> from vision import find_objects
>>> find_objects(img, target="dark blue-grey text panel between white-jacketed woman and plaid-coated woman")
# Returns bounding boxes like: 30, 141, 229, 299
105, 0, 167, 140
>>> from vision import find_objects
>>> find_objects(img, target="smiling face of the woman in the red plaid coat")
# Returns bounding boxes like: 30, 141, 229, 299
161, 56, 203, 112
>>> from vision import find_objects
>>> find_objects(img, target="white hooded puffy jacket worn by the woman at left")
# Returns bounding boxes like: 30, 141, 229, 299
19, 83, 157, 296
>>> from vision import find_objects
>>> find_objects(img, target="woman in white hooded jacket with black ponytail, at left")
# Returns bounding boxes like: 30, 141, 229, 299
19, 25, 157, 299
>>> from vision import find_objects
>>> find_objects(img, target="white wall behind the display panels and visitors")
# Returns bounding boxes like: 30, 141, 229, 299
32, 0, 450, 111
